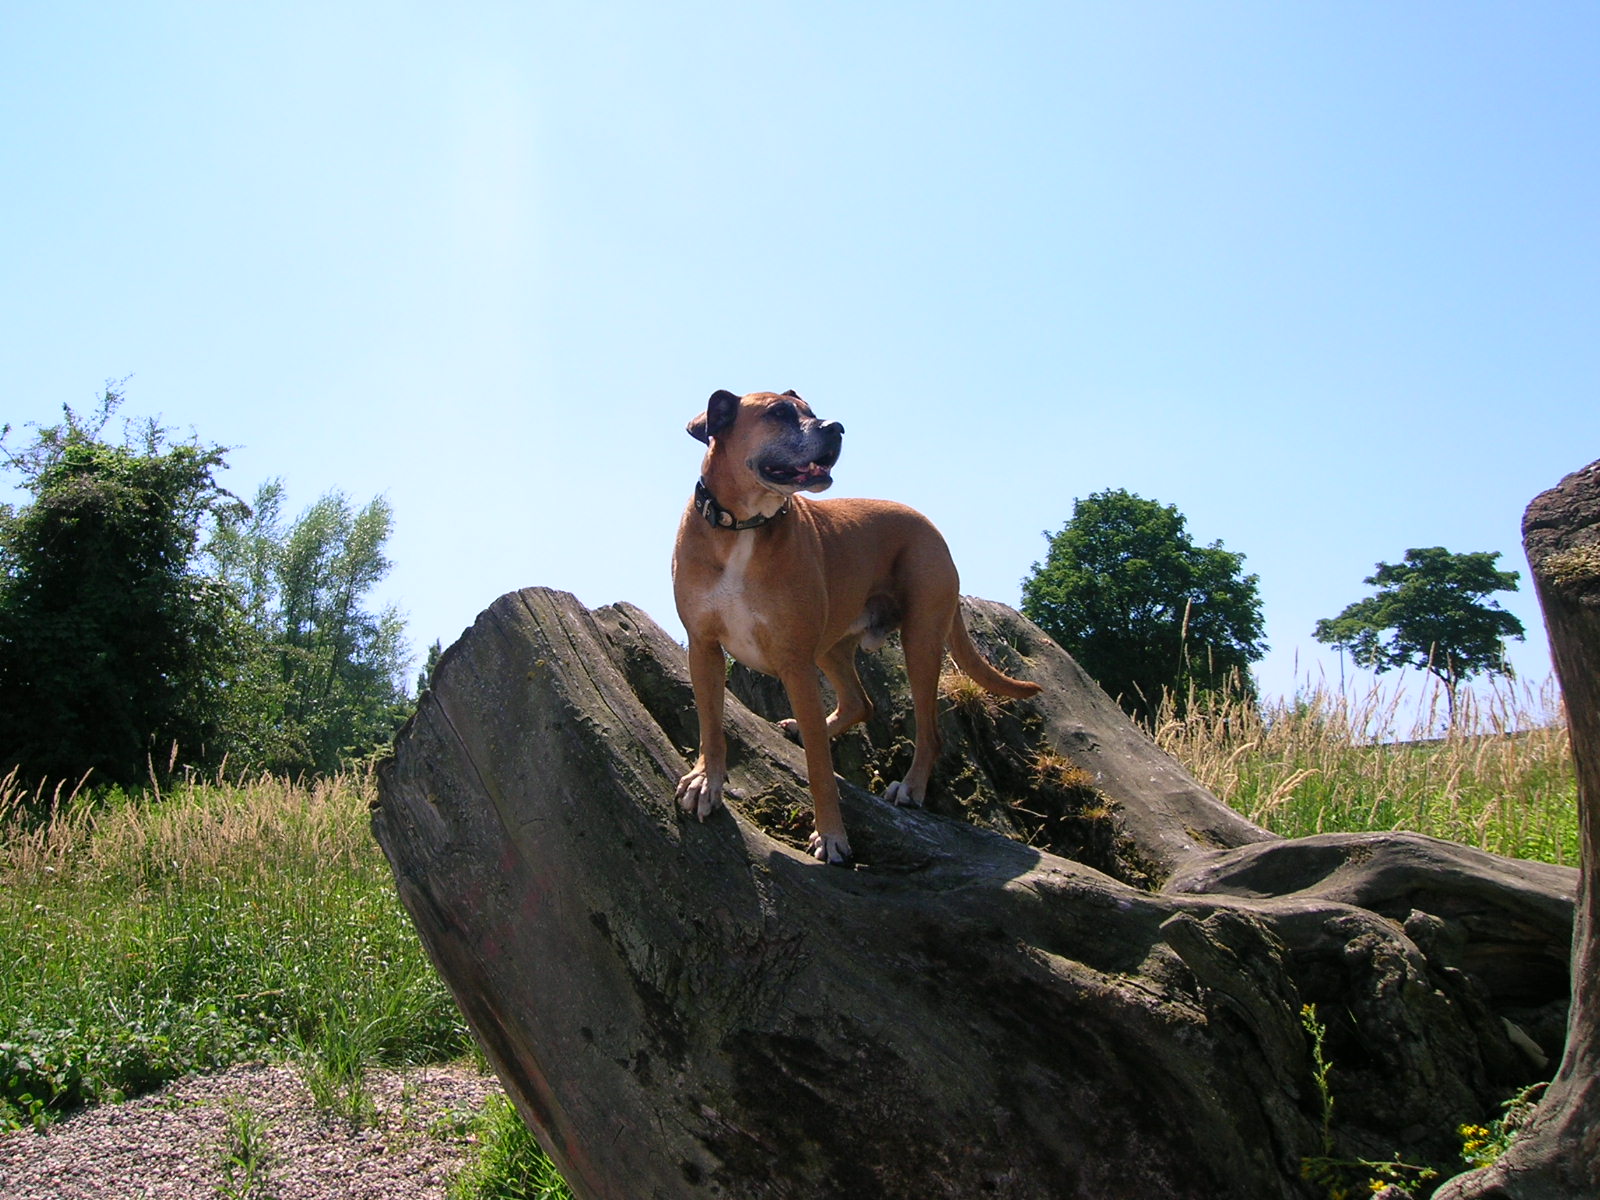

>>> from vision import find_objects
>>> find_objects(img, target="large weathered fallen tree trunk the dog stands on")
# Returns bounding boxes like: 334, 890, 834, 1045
374, 589, 1576, 1200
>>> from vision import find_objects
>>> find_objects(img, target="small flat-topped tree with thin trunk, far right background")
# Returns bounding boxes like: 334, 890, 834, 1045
1312, 546, 1523, 723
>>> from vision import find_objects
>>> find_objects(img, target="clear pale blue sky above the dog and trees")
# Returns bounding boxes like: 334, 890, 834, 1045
0, 0, 1600, 713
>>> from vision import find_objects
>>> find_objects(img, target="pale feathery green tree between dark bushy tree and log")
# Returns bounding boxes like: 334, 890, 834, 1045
210, 480, 406, 773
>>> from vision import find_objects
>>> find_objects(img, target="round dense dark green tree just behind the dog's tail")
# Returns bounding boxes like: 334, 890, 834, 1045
1022, 488, 1267, 722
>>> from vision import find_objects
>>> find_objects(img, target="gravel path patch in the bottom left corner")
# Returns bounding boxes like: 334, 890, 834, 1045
0, 1066, 499, 1200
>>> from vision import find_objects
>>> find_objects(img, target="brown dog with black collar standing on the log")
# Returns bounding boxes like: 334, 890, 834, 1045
672, 392, 1038, 862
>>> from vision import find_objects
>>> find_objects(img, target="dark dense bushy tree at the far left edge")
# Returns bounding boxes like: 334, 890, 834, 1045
0, 384, 238, 782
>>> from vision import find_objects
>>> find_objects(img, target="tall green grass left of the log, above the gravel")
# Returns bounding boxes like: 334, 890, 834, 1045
0, 776, 470, 1128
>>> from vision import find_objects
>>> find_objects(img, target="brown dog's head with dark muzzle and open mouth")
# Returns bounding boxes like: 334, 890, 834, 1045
688, 392, 845, 494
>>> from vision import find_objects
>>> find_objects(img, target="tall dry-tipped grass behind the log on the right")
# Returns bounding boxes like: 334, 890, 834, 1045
1155, 682, 1578, 866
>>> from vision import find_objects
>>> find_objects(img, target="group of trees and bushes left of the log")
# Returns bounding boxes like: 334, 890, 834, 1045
0, 384, 410, 787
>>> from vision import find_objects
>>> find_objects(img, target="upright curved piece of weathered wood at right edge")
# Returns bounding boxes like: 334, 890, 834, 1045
1440, 461, 1600, 1200
